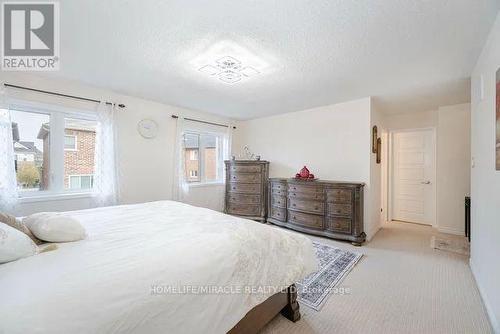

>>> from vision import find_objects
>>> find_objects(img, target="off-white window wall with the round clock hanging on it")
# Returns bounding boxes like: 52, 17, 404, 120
0, 72, 237, 215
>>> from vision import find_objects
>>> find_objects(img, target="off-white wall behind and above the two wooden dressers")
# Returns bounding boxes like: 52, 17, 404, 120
233, 98, 379, 238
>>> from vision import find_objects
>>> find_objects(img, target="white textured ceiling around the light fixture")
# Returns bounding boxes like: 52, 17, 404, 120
44, 0, 500, 119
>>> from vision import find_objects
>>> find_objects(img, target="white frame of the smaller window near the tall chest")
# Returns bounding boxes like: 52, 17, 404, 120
181, 128, 226, 187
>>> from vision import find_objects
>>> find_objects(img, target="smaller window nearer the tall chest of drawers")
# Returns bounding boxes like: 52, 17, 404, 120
184, 131, 223, 183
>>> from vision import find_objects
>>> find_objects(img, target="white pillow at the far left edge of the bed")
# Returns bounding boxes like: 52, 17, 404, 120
0, 223, 38, 263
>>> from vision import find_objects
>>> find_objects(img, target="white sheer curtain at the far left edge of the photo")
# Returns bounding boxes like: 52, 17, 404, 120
0, 85, 19, 212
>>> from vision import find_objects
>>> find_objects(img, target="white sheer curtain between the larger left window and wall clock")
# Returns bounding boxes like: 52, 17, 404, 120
94, 102, 119, 206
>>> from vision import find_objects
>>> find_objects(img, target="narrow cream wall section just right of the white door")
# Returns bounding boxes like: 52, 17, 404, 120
436, 103, 470, 235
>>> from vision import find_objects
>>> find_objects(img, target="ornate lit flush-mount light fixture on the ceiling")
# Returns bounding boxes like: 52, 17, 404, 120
198, 56, 260, 84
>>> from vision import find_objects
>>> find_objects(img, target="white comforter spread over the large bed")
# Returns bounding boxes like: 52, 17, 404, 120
0, 201, 316, 334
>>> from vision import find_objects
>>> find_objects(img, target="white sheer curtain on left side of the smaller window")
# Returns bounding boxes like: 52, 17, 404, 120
172, 116, 189, 202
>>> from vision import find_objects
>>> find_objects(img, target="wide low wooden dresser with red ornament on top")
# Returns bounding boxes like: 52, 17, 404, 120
267, 179, 366, 246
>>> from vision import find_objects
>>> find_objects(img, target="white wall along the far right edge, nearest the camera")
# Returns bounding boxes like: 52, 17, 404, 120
470, 11, 500, 333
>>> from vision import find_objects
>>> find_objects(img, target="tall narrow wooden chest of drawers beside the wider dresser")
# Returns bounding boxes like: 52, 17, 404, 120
224, 160, 269, 222
